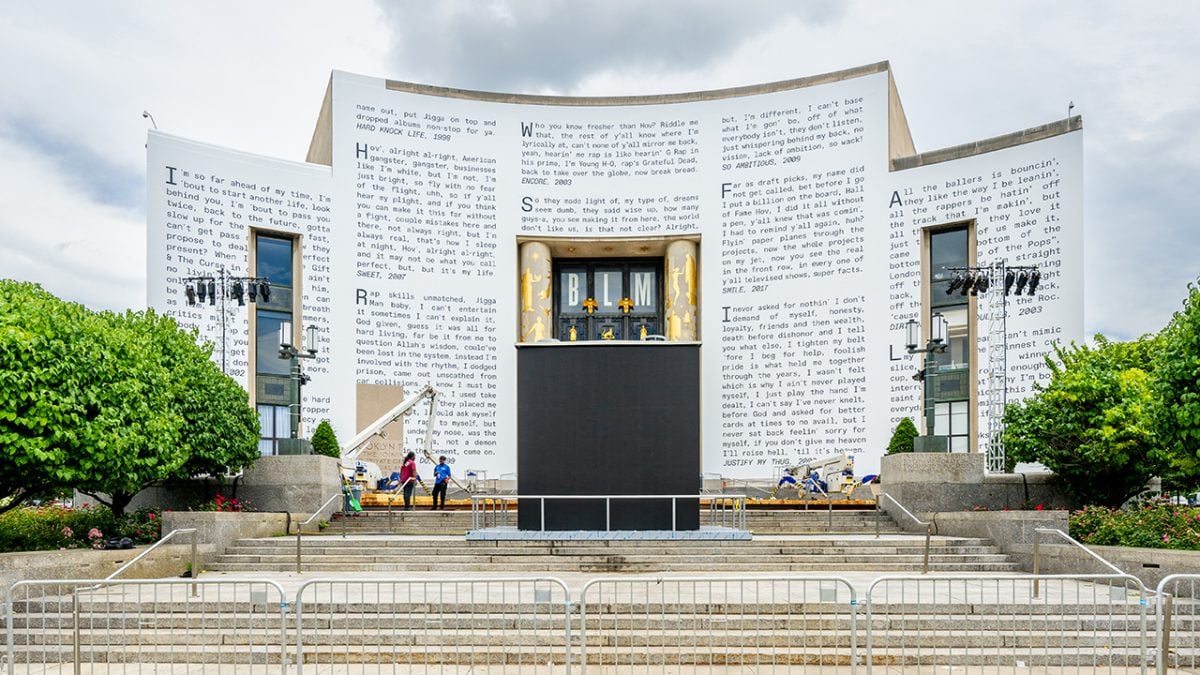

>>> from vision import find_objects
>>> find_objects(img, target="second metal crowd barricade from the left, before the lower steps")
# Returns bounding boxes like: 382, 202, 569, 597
294, 578, 571, 674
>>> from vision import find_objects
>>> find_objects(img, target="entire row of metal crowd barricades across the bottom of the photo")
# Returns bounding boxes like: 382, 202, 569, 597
9, 573, 1200, 675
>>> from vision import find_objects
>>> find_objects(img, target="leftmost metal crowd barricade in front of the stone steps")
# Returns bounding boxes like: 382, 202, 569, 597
6, 571, 288, 675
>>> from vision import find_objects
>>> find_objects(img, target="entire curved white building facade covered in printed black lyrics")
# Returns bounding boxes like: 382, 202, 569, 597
148, 63, 1084, 477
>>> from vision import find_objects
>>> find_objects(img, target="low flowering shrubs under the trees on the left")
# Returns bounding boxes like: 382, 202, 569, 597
0, 507, 162, 552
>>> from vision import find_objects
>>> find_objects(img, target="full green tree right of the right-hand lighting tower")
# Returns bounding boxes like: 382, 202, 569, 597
1003, 335, 1166, 508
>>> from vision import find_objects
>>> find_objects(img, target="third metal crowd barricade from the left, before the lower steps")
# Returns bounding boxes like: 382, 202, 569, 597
578, 577, 859, 674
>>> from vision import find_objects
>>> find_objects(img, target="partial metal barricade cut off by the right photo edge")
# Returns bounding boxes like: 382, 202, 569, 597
1154, 574, 1200, 675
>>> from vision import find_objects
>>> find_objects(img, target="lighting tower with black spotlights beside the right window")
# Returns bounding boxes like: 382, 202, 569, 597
946, 259, 1042, 473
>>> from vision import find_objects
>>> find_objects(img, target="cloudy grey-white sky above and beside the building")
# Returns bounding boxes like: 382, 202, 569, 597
0, 0, 1200, 338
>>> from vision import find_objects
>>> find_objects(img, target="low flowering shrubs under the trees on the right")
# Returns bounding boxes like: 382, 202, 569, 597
1070, 500, 1200, 551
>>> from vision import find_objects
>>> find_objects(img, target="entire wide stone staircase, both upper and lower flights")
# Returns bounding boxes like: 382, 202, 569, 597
12, 510, 1200, 673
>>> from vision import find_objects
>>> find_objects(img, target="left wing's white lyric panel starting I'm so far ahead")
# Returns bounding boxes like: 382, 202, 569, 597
146, 132, 347, 430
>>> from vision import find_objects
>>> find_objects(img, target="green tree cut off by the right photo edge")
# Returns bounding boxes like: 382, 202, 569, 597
1154, 276, 1200, 488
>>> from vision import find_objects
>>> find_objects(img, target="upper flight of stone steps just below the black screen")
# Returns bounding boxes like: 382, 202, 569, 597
208, 510, 1018, 574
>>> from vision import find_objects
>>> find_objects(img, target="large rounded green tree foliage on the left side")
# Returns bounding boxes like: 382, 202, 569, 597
0, 280, 259, 515
